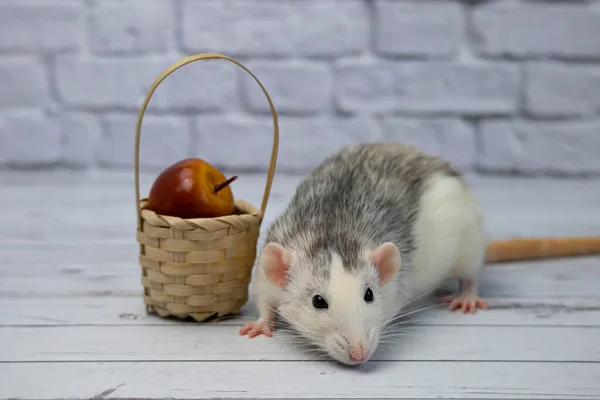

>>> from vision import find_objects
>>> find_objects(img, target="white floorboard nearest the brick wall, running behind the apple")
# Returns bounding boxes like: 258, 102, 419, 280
0, 172, 600, 248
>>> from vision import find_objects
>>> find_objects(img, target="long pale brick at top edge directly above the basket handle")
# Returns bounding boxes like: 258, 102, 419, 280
181, 0, 369, 57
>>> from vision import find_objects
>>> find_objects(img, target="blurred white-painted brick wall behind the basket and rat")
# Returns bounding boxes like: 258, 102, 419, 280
0, 0, 600, 175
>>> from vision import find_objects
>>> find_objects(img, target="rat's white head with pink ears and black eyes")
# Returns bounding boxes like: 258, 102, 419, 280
261, 242, 401, 364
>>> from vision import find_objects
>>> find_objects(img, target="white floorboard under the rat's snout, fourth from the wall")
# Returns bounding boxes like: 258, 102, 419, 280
0, 324, 600, 366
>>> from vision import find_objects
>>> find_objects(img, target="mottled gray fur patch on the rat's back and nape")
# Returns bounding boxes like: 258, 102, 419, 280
266, 143, 460, 288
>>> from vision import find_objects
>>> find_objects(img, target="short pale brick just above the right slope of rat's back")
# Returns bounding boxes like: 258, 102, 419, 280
381, 117, 476, 170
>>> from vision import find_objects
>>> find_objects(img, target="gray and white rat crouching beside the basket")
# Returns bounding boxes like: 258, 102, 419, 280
239, 143, 600, 365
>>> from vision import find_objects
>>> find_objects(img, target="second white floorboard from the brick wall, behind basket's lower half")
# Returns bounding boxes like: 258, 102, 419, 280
0, 245, 600, 299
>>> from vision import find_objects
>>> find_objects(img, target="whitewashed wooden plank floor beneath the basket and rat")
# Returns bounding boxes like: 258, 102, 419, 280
0, 172, 600, 399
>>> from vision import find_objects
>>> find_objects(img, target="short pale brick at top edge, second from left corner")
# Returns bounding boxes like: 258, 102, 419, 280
90, 0, 175, 54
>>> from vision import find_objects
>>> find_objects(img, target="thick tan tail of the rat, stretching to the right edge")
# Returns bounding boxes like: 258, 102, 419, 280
486, 236, 600, 263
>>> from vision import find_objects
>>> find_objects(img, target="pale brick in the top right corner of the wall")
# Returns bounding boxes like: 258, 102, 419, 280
472, 1, 600, 58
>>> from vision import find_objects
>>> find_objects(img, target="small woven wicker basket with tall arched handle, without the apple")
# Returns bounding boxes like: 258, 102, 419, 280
135, 53, 279, 322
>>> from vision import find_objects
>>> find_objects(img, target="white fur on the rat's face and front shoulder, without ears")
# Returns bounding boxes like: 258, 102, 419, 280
254, 245, 394, 364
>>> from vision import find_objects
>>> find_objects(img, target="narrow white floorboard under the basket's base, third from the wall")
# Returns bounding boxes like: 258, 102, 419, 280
0, 296, 600, 329
